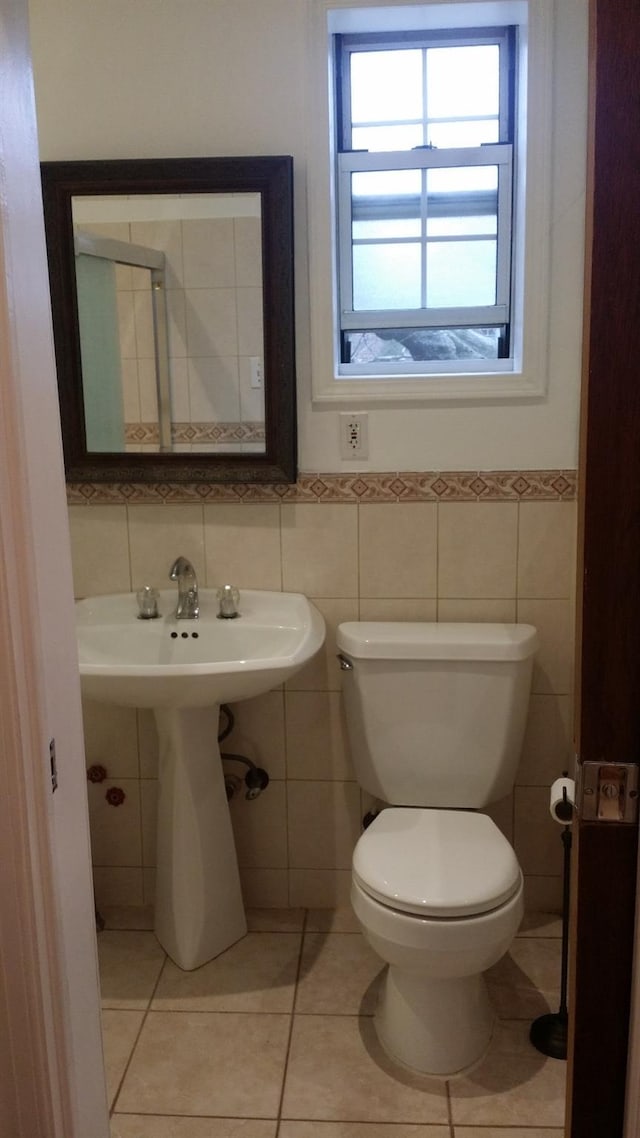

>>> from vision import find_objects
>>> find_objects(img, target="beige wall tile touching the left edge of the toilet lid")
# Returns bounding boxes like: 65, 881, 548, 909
287, 781, 361, 869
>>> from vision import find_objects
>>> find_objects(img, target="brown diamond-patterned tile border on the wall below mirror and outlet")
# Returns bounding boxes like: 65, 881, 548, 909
67, 470, 577, 505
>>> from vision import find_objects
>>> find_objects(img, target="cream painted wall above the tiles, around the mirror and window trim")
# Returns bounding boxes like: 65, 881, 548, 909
30, 0, 588, 471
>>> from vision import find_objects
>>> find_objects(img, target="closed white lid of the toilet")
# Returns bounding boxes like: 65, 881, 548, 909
353, 807, 520, 917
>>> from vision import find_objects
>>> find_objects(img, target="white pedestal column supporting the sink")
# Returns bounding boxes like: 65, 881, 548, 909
155, 706, 247, 971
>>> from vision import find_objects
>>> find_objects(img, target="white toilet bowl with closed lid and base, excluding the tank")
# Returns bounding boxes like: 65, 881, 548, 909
351, 807, 524, 1074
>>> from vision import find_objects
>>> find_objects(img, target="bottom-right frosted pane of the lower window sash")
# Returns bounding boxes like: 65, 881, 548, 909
427, 240, 497, 308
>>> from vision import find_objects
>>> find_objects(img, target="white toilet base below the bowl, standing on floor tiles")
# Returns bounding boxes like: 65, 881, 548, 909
375, 964, 495, 1075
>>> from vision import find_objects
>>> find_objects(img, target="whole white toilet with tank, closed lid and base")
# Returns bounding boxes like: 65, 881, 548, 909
337, 621, 538, 1074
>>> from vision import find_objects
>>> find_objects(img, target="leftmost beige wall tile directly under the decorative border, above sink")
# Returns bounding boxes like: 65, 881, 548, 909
68, 505, 131, 596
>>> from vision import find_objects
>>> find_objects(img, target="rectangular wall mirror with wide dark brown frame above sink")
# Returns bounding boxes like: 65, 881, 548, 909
41, 156, 296, 483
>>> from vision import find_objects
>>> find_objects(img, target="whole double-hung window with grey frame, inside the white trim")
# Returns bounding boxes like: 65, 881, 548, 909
334, 27, 517, 377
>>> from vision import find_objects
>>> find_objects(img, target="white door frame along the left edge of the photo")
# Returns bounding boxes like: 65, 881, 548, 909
0, 0, 109, 1138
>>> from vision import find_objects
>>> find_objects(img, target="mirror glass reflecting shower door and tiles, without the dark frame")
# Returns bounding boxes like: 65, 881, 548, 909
72, 192, 265, 454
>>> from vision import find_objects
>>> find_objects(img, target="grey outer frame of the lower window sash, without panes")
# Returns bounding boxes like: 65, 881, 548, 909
337, 143, 514, 332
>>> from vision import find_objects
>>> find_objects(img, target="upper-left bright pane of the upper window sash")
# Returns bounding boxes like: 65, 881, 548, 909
351, 48, 423, 123
